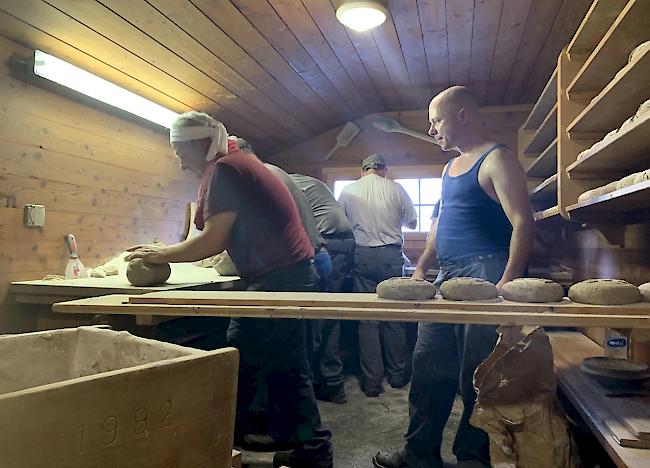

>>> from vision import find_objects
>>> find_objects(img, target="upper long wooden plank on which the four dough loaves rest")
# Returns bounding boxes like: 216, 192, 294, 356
126, 291, 650, 315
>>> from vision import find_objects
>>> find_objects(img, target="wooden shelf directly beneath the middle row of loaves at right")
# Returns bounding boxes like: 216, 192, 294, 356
567, 112, 650, 179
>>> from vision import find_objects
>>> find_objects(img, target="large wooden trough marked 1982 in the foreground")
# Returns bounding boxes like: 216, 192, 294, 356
0, 327, 239, 468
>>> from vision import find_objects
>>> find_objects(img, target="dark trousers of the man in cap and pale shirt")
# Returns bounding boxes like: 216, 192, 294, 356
353, 245, 408, 388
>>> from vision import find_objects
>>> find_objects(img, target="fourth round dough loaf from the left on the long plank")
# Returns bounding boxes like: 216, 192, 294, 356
569, 279, 642, 305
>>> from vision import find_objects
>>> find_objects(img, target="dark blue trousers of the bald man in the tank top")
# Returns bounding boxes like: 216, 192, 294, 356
405, 254, 507, 466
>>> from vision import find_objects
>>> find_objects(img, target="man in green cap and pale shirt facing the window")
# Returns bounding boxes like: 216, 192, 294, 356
339, 154, 417, 397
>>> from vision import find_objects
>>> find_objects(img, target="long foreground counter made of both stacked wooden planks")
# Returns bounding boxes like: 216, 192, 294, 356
53, 291, 650, 328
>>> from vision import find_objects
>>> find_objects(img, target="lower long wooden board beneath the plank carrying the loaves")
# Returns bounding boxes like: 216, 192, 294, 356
52, 293, 650, 328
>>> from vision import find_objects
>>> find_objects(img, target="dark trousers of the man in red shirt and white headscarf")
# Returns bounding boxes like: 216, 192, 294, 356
228, 262, 332, 468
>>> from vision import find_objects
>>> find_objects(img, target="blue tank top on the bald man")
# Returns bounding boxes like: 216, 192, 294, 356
436, 144, 512, 261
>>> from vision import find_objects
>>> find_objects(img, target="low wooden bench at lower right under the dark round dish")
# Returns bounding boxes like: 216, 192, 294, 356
549, 332, 650, 467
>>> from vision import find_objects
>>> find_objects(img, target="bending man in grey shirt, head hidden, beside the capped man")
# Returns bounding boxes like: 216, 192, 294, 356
291, 174, 355, 403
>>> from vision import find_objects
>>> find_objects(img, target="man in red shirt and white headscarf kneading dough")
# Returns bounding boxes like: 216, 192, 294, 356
127, 112, 332, 468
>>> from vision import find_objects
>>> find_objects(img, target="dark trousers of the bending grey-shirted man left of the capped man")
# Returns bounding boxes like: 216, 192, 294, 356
310, 238, 355, 387
